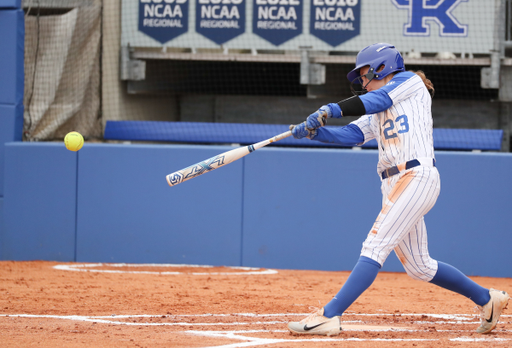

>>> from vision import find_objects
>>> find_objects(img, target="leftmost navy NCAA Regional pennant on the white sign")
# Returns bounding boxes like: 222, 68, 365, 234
139, 0, 189, 44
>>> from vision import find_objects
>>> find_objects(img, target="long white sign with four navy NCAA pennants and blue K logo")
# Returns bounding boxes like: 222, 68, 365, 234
121, 0, 499, 54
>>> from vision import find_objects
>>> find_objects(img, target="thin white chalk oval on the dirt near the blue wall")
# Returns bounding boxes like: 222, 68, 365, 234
53, 263, 278, 275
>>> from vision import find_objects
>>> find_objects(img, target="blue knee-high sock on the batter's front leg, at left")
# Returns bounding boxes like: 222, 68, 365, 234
324, 256, 381, 318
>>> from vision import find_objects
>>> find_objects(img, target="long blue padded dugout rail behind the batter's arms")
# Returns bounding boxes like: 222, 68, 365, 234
179, 95, 502, 129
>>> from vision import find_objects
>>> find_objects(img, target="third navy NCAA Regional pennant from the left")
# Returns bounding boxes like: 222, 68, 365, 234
252, 0, 303, 46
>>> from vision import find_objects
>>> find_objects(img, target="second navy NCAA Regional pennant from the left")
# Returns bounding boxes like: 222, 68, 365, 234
196, 0, 246, 45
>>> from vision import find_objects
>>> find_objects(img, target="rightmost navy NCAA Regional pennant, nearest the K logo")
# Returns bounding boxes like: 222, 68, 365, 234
309, 0, 361, 47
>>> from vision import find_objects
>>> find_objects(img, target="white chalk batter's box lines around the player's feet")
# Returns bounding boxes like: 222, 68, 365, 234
0, 313, 512, 348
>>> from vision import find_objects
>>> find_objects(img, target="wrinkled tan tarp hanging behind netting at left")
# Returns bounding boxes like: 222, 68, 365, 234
24, 2, 102, 140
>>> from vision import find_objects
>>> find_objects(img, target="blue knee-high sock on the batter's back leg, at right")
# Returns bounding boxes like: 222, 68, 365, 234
430, 261, 491, 306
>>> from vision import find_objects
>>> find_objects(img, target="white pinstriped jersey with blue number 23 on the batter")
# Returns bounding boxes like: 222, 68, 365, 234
352, 72, 434, 174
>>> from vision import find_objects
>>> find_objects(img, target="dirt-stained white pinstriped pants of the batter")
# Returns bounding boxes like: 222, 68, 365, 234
361, 165, 441, 281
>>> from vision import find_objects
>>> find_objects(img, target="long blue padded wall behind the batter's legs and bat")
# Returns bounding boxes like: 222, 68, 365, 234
0, 142, 512, 277
